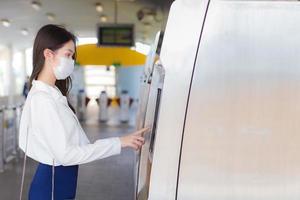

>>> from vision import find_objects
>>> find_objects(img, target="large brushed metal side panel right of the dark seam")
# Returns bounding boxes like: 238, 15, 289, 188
178, 0, 300, 200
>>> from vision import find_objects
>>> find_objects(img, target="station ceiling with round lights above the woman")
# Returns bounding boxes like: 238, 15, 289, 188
0, 0, 172, 49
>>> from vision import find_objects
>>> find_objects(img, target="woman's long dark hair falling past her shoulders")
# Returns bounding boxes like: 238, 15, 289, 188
29, 24, 77, 113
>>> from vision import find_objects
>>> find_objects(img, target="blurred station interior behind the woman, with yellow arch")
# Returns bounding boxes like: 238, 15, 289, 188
0, 0, 172, 200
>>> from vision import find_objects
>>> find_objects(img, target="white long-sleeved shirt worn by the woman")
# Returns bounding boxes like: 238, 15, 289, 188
19, 80, 121, 166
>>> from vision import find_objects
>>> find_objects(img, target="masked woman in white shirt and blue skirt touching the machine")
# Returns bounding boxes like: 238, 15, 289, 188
19, 25, 147, 200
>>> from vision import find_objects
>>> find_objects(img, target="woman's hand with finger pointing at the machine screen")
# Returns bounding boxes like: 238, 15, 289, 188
120, 128, 150, 150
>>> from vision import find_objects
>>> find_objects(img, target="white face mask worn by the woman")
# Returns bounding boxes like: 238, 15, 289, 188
54, 57, 74, 80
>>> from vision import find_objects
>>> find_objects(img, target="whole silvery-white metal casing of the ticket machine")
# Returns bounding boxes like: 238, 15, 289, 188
134, 0, 300, 200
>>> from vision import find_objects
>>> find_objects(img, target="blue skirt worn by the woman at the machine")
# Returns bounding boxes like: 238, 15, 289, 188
28, 163, 78, 200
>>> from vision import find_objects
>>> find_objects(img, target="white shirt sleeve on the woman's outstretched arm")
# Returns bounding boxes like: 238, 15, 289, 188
30, 92, 121, 166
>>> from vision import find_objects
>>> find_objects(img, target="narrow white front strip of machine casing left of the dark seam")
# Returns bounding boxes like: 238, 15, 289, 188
149, 0, 208, 200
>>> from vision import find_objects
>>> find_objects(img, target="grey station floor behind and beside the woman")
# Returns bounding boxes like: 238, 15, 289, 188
0, 101, 135, 200
